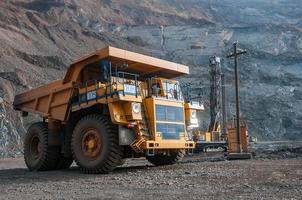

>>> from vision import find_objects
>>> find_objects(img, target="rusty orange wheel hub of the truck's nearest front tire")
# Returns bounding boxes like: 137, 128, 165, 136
82, 129, 101, 159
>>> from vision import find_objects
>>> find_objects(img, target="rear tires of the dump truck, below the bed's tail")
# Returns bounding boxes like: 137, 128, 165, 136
24, 122, 60, 171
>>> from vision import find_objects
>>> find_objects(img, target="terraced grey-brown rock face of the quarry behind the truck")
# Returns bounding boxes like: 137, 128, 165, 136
0, 0, 302, 156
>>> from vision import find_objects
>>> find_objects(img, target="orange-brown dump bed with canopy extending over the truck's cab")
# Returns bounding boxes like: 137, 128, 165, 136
14, 46, 189, 121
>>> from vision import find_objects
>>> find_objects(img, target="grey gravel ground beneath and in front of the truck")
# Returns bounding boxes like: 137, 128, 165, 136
0, 145, 302, 199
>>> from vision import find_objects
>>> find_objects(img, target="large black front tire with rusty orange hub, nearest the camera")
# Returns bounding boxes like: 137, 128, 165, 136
71, 114, 122, 174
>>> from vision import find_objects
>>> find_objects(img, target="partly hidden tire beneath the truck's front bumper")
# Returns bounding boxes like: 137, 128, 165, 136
146, 150, 185, 166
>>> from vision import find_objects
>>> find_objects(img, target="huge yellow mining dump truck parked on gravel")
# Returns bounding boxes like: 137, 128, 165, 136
14, 47, 203, 173
